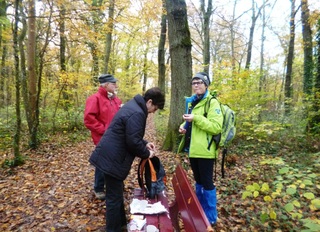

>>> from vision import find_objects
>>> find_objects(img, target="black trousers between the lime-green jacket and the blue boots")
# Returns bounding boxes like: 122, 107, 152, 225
190, 158, 215, 190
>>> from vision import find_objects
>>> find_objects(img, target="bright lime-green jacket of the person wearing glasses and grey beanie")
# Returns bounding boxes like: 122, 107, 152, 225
178, 94, 223, 159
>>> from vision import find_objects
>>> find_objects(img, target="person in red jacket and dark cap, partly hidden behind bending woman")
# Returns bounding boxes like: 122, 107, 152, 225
84, 74, 122, 200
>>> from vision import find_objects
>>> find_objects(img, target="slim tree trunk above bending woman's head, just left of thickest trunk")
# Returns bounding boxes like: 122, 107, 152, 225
158, 0, 167, 93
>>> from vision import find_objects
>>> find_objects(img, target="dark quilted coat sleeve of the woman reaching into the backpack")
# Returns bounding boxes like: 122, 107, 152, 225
126, 112, 150, 159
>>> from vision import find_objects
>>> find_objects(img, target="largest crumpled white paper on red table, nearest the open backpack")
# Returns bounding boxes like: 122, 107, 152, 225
130, 198, 168, 214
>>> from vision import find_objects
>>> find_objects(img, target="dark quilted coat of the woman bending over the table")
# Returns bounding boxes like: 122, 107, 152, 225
89, 94, 150, 180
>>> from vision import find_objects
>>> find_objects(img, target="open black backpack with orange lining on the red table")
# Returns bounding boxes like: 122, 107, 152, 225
138, 156, 166, 199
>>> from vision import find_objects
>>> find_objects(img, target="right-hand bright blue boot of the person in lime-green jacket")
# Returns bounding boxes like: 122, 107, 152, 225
202, 189, 218, 225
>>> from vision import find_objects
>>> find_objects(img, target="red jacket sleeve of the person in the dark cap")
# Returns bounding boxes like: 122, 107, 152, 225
84, 96, 105, 135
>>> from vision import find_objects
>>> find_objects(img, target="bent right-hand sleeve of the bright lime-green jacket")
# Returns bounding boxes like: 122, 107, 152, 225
193, 99, 223, 135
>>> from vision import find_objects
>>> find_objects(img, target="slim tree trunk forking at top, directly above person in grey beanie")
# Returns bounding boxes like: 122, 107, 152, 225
200, 0, 212, 74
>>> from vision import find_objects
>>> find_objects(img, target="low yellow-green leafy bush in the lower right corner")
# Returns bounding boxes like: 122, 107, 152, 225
242, 154, 320, 231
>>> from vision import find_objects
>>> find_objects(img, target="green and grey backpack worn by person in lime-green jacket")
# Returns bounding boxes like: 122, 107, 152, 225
203, 95, 236, 178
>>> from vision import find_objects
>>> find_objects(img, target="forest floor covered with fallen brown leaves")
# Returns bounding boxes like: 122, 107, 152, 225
0, 115, 318, 232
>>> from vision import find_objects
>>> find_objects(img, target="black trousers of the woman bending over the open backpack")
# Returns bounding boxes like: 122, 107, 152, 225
105, 175, 127, 232
